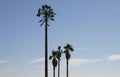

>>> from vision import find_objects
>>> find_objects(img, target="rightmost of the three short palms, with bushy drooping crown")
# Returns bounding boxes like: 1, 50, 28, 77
64, 44, 74, 77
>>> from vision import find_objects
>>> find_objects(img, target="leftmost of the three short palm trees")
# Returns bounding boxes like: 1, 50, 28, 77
49, 51, 57, 77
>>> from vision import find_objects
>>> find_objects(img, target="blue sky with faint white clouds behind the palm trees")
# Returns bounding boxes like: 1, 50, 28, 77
0, 0, 120, 77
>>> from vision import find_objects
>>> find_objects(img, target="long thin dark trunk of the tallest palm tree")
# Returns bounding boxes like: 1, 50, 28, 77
45, 14, 48, 77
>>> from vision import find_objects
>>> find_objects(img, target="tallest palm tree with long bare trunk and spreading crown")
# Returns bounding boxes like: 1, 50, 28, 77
37, 5, 56, 77
